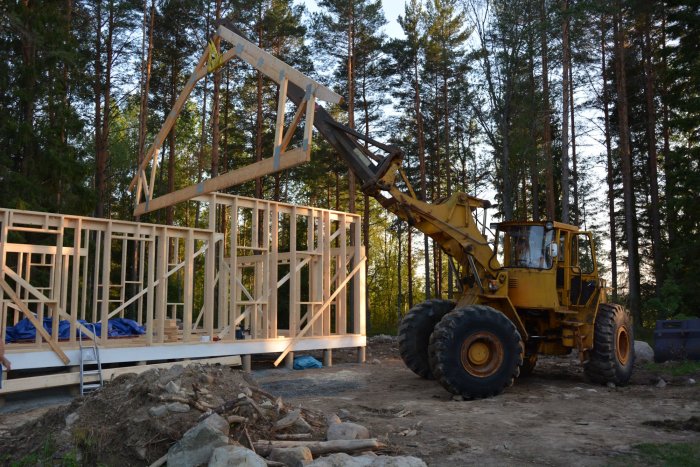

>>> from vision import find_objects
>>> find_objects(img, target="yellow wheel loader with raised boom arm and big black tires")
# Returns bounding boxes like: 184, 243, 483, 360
223, 23, 634, 399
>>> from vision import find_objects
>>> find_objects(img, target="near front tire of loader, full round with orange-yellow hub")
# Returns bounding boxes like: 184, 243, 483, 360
429, 305, 524, 399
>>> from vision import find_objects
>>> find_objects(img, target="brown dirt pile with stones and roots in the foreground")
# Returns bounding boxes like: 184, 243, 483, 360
0, 364, 326, 465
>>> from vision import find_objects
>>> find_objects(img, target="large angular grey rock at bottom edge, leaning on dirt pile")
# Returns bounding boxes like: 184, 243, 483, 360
168, 414, 229, 467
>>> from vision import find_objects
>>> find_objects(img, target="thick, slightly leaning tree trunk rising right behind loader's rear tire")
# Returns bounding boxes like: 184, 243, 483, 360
614, 1, 642, 326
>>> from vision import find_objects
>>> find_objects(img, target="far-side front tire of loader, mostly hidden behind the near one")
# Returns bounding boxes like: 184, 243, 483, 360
399, 299, 455, 379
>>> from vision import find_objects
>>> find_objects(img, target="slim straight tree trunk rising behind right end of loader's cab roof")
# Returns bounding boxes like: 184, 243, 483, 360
561, 0, 570, 224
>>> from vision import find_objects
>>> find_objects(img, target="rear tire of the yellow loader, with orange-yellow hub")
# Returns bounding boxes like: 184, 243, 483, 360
584, 303, 635, 386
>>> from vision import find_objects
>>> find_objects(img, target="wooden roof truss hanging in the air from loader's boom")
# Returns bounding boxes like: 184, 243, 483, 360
129, 25, 342, 216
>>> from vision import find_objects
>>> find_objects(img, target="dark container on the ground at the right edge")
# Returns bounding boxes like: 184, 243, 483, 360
654, 319, 700, 363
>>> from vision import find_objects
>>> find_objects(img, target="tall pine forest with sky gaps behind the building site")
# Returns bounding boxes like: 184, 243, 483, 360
0, 0, 700, 333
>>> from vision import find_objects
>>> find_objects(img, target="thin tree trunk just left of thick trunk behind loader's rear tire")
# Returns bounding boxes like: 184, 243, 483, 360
600, 18, 617, 300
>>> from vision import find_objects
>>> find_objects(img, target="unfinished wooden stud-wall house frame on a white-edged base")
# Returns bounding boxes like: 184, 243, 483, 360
0, 197, 366, 394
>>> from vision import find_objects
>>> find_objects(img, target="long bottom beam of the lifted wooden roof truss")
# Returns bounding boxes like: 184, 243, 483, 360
134, 148, 308, 216
